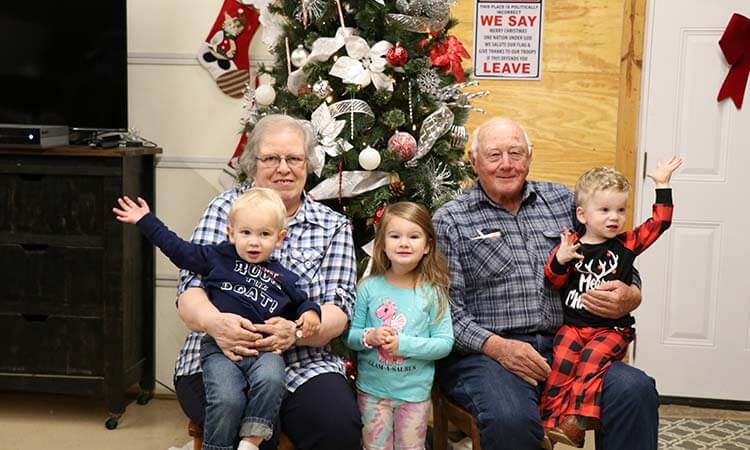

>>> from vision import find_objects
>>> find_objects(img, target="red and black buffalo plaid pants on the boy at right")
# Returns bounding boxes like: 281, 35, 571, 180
539, 325, 635, 428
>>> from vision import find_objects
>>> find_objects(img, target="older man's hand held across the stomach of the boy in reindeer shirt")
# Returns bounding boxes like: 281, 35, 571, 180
581, 280, 641, 319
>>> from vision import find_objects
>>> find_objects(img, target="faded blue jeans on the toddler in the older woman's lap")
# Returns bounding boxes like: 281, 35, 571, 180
201, 336, 286, 450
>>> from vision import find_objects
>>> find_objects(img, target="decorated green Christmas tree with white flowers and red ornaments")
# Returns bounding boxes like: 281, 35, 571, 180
243, 0, 485, 260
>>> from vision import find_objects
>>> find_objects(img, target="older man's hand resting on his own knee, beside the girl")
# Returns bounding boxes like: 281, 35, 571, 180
482, 336, 551, 386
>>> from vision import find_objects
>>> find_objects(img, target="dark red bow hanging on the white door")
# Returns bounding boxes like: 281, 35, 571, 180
716, 13, 750, 109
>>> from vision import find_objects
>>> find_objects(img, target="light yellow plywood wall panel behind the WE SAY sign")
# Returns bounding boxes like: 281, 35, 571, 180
452, 0, 623, 186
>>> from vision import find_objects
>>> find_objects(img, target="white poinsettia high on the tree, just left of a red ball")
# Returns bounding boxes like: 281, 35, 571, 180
329, 36, 393, 91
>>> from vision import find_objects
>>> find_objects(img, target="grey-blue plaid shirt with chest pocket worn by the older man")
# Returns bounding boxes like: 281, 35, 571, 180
433, 181, 640, 352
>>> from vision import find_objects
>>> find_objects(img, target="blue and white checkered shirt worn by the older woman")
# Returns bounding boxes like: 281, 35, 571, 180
175, 186, 356, 392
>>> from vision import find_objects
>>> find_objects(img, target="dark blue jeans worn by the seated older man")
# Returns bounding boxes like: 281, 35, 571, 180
437, 334, 659, 450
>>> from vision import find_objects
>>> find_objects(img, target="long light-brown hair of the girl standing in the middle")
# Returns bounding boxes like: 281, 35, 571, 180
370, 202, 450, 319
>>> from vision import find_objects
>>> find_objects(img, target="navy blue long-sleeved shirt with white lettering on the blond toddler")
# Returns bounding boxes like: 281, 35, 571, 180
136, 213, 320, 323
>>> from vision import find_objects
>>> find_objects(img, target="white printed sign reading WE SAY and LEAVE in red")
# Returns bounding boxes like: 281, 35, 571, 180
473, 0, 544, 80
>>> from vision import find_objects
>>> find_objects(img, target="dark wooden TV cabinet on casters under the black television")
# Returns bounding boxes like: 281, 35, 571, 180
0, 146, 161, 429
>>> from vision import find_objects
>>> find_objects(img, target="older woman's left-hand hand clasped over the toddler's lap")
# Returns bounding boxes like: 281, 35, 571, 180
206, 313, 262, 361
